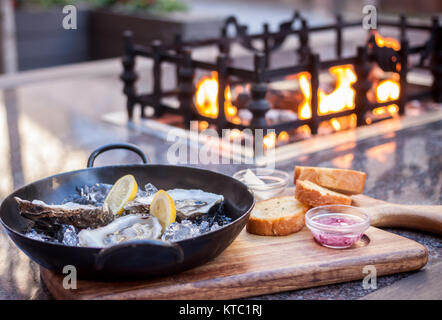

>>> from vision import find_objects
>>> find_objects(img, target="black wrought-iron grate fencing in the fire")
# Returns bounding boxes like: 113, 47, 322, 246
121, 12, 442, 134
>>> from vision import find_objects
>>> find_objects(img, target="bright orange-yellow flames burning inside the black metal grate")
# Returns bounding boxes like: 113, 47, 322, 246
195, 56, 400, 148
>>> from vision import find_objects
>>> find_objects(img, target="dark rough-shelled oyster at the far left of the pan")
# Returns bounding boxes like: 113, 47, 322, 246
14, 197, 115, 229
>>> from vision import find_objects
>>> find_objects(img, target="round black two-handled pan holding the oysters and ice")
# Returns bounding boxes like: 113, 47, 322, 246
0, 144, 254, 280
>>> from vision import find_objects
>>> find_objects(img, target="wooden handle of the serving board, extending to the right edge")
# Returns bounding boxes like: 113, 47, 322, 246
352, 194, 442, 235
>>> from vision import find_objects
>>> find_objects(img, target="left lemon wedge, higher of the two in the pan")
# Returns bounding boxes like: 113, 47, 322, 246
103, 174, 138, 214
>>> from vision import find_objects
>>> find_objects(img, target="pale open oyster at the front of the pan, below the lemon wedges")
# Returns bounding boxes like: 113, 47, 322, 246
78, 214, 162, 248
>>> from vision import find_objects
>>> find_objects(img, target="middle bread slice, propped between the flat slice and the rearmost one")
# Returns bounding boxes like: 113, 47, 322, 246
295, 180, 351, 207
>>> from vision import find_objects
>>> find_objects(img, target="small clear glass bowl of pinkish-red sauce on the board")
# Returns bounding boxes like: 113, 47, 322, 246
305, 205, 370, 249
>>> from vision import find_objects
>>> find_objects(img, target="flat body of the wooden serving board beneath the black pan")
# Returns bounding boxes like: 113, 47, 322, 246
41, 227, 428, 300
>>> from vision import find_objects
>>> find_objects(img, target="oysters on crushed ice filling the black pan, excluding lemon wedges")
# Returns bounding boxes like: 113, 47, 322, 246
15, 183, 231, 248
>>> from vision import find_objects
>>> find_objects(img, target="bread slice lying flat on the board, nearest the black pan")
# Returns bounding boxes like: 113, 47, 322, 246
247, 196, 309, 236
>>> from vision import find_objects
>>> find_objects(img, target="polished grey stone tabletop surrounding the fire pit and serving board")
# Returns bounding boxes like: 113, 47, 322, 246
0, 60, 442, 299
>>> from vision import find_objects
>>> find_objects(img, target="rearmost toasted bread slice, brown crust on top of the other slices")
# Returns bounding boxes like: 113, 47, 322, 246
294, 166, 366, 194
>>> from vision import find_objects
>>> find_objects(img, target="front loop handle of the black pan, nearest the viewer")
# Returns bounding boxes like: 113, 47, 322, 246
95, 240, 184, 275
